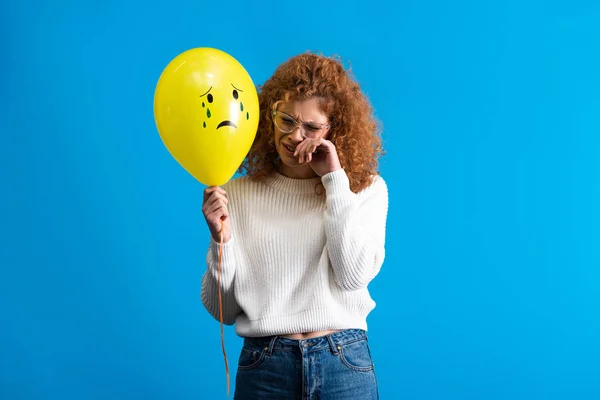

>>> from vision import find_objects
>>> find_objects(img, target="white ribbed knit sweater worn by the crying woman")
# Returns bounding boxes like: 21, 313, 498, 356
201, 169, 388, 337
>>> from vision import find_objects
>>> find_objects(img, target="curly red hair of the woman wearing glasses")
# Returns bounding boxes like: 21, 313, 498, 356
240, 53, 384, 193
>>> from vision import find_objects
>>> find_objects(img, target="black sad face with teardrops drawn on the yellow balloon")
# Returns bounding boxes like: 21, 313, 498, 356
200, 83, 250, 130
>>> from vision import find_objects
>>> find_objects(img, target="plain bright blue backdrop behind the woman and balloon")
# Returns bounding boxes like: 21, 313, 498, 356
0, 0, 600, 400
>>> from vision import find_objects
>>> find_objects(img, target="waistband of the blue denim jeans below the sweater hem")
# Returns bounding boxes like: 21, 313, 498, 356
244, 329, 368, 354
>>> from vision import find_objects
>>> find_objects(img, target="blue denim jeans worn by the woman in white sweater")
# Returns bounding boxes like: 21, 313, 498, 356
234, 329, 379, 400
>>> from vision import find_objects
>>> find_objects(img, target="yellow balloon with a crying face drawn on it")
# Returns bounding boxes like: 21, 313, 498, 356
154, 47, 259, 186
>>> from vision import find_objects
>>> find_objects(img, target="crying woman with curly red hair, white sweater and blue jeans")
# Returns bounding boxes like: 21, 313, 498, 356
201, 54, 388, 400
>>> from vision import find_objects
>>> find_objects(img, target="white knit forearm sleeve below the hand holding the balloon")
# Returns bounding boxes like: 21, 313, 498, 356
200, 237, 242, 325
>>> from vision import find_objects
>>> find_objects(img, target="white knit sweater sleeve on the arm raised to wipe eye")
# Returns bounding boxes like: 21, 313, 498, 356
322, 169, 388, 290
